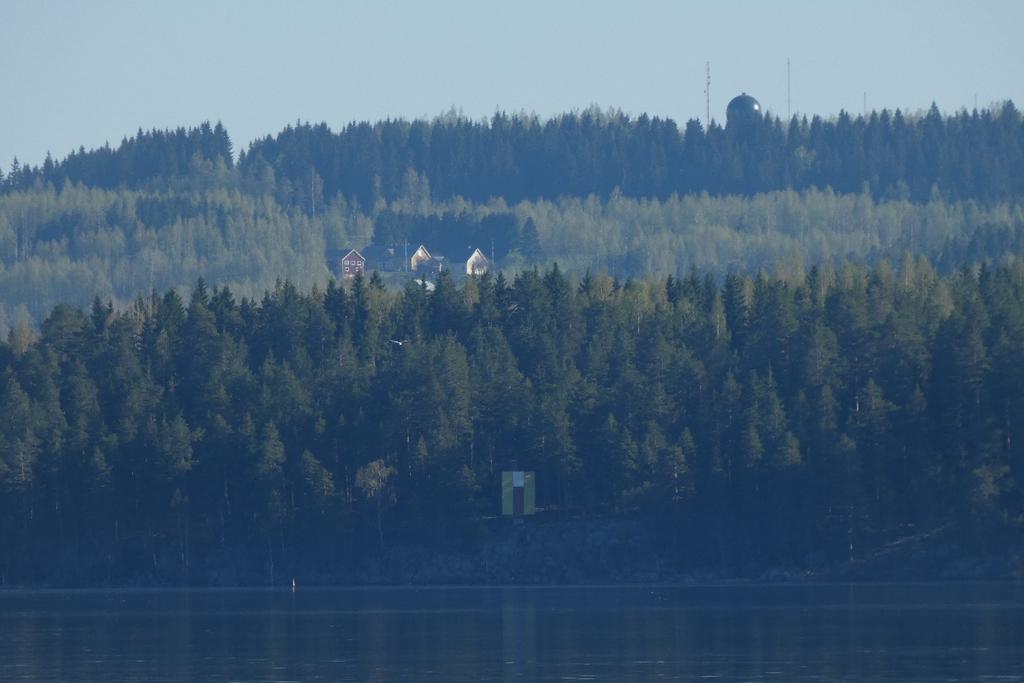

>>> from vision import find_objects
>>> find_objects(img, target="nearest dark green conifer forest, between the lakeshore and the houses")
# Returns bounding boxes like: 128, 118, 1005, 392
0, 264, 1024, 582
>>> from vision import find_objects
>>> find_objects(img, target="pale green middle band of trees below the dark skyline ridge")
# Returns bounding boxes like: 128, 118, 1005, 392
0, 176, 1024, 327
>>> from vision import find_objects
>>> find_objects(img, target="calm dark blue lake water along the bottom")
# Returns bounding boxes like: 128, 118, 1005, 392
0, 584, 1024, 681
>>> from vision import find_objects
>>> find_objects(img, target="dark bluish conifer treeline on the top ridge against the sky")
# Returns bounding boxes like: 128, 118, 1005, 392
3, 102, 1024, 209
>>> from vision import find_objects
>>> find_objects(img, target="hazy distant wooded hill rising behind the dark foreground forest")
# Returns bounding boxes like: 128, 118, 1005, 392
0, 102, 1024, 336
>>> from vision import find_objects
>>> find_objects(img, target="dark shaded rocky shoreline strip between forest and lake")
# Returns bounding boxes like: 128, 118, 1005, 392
0, 514, 1024, 590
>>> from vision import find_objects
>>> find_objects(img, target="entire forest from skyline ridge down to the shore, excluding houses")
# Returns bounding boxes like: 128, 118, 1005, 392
0, 102, 1024, 585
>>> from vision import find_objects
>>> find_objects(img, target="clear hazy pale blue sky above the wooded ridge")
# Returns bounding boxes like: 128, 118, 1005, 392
0, 0, 1024, 169
